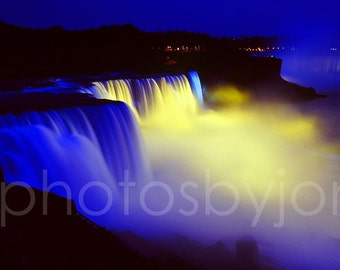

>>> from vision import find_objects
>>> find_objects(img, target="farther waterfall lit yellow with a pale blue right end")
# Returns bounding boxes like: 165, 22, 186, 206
84, 71, 203, 117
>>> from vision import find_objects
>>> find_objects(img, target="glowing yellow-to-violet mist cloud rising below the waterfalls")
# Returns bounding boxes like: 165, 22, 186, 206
104, 88, 340, 269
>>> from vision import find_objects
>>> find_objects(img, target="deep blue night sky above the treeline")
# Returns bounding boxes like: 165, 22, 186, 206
0, 0, 340, 37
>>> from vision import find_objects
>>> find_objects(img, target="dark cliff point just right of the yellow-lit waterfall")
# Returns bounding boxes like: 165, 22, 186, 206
200, 57, 323, 102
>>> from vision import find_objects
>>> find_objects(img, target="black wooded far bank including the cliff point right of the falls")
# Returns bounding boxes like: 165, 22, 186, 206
0, 22, 315, 100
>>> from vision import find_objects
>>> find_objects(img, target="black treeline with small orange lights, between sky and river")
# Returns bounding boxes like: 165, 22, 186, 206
0, 22, 277, 79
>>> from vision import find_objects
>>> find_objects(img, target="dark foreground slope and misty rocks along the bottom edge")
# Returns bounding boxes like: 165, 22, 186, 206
0, 180, 277, 270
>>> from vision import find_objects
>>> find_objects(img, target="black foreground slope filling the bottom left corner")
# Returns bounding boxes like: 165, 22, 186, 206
0, 183, 147, 269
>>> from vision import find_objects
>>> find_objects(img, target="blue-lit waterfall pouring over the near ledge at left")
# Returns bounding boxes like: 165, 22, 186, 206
0, 102, 151, 215
